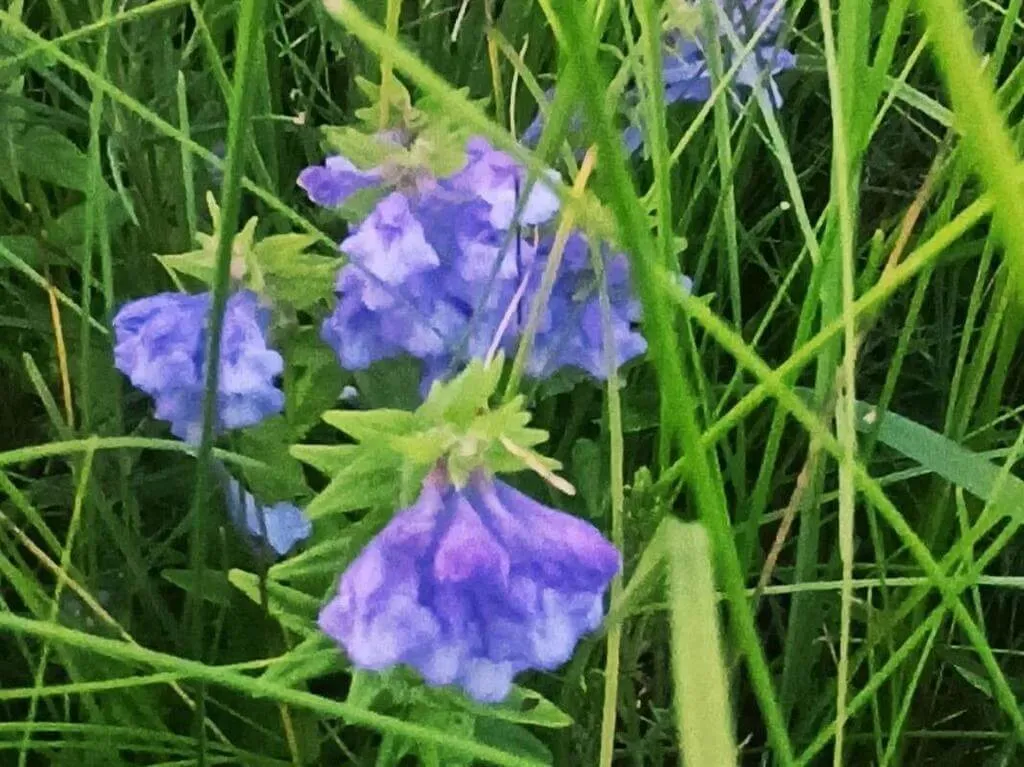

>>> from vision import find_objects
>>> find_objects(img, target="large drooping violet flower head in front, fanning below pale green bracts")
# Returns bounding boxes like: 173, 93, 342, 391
319, 470, 620, 701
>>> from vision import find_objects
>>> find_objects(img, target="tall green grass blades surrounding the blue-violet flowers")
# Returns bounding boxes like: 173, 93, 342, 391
0, 0, 1024, 767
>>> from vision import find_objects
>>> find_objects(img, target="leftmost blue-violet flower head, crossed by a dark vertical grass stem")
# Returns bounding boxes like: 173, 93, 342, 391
114, 291, 285, 443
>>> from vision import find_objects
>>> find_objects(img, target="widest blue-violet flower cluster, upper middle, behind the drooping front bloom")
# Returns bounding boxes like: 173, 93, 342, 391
299, 137, 645, 388
